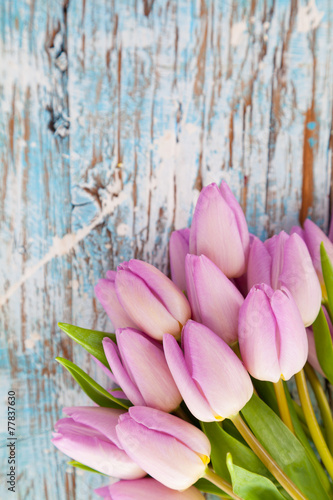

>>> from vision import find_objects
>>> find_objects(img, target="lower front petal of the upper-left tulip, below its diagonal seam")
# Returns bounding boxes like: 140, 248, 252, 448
116, 270, 181, 340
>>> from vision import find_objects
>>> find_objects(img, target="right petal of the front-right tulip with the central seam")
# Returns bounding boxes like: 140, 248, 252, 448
271, 288, 308, 380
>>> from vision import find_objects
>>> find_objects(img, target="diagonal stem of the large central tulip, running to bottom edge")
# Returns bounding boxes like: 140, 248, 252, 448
231, 413, 307, 500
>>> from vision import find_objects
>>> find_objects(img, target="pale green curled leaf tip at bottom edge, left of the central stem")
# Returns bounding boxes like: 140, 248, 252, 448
227, 453, 284, 500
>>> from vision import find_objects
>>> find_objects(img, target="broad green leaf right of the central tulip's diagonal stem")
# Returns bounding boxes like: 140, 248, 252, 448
241, 394, 329, 500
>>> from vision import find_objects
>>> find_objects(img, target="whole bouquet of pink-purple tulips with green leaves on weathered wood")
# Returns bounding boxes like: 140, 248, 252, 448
53, 182, 333, 500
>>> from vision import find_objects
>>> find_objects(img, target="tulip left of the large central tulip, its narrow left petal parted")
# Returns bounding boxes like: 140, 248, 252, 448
103, 328, 182, 412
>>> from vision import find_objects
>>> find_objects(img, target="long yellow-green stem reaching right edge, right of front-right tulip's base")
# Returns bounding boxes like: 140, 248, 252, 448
295, 370, 333, 478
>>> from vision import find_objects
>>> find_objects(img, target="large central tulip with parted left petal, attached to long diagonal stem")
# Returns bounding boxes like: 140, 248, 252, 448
163, 321, 253, 422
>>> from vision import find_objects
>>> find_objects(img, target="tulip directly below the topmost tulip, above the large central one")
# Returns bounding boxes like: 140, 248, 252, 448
185, 255, 244, 344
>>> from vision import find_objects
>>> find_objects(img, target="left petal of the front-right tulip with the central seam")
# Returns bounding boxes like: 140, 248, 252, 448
238, 284, 281, 382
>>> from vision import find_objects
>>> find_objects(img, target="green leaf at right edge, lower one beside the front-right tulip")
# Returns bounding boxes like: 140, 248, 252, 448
312, 309, 333, 384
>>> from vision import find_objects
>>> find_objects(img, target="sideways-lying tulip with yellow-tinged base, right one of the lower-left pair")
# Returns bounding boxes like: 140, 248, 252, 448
116, 406, 211, 490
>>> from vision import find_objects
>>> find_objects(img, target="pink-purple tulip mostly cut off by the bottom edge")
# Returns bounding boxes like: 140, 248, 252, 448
95, 477, 205, 500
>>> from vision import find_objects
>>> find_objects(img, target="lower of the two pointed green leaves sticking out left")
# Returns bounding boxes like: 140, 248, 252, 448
56, 358, 128, 410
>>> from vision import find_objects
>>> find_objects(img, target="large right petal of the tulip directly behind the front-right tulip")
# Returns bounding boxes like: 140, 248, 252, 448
278, 233, 321, 326
